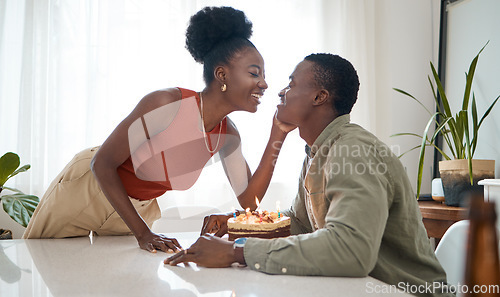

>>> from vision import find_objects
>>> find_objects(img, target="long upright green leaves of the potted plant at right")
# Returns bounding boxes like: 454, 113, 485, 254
391, 41, 500, 197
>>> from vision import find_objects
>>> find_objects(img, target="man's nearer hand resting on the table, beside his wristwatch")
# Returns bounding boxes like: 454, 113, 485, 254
163, 234, 236, 268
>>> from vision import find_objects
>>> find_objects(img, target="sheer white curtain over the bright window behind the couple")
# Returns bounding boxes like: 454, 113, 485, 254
0, 0, 434, 210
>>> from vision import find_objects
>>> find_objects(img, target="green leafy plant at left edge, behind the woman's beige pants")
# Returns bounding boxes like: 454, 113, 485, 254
0, 153, 40, 227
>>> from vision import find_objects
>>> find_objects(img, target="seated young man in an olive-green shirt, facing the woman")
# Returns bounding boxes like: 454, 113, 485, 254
165, 54, 452, 296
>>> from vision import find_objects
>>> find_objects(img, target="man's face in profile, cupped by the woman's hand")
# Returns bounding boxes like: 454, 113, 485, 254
277, 60, 319, 127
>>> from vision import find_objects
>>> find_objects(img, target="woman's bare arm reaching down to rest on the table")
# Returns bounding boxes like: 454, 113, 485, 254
91, 89, 181, 252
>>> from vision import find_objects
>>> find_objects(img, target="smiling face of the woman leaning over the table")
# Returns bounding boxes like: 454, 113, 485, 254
225, 47, 267, 112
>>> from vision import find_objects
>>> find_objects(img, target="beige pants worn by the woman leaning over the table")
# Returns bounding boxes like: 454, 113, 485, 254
23, 147, 161, 238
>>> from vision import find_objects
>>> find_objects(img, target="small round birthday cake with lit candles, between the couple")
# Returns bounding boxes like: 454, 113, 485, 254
227, 211, 290, 240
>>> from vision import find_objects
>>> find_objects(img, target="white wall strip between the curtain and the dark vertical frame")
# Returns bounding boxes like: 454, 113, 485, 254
372, 0, 440, 193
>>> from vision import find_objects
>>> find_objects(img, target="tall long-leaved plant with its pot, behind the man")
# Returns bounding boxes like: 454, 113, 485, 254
392, 41, 500, 206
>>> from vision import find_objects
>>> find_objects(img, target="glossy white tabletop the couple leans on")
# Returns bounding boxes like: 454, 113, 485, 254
0, 232, 410, 297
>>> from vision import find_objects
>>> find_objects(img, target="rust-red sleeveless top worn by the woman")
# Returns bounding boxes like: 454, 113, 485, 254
117, 88, 227, 200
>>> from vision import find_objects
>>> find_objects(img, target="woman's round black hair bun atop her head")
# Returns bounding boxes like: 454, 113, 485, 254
186, 6, 252, 63
